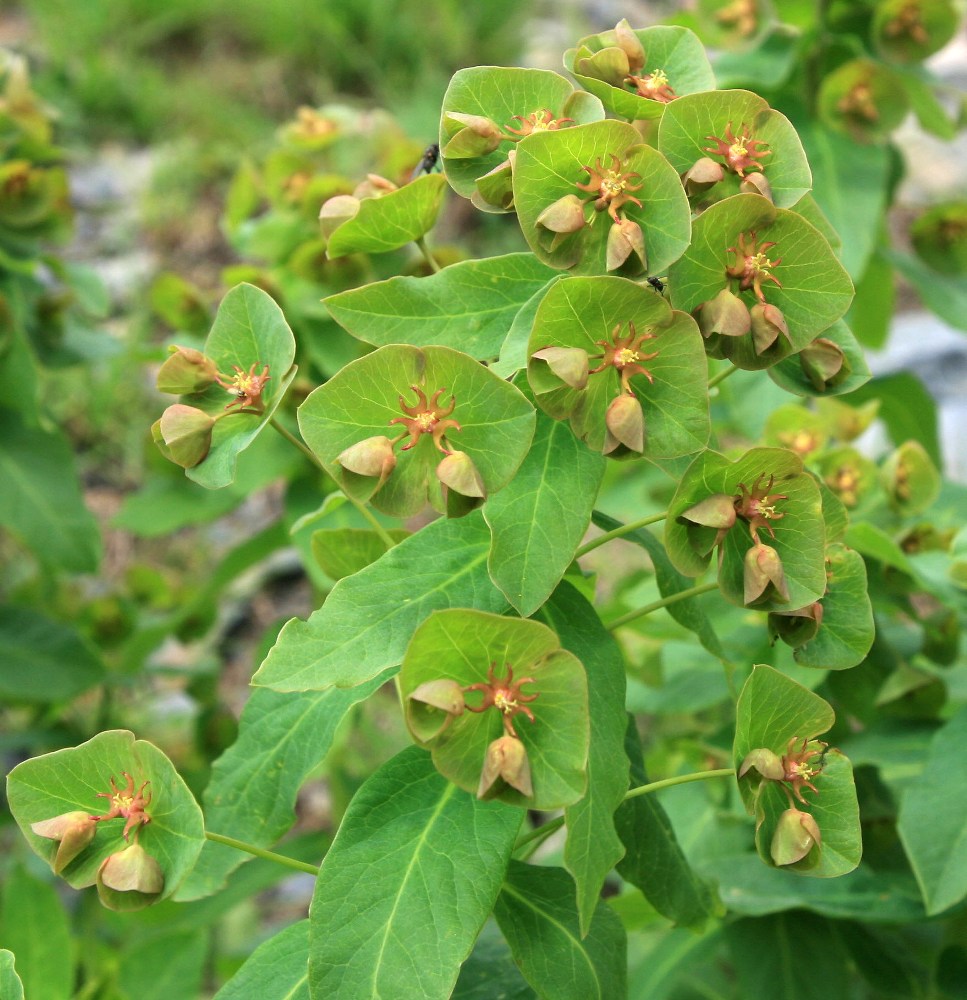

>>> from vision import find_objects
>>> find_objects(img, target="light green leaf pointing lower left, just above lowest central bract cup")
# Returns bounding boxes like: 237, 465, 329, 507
253, 512, 507, 691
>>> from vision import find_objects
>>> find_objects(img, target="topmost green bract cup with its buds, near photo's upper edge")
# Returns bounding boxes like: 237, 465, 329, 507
564, 22, 715, 120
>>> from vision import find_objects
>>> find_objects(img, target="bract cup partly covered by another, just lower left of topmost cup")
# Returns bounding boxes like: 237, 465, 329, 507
440, 66, 604, 212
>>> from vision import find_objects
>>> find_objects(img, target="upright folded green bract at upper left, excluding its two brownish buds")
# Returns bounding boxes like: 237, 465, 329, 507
181, 284, 295, 490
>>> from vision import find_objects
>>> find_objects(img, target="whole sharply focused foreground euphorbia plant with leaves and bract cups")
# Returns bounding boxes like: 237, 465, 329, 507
10, 13, 917, 1000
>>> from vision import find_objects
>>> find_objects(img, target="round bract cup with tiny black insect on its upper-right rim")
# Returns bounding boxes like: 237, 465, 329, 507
527, 276, 709, 458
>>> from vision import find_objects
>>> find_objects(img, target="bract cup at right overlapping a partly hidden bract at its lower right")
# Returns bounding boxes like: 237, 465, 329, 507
665, 448, 826, 611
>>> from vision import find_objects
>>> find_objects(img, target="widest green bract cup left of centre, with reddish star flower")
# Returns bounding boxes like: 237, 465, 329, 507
299, 345, 536, 517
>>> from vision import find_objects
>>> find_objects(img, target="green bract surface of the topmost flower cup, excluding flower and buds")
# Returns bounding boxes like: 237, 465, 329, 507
564, 25, 715, 120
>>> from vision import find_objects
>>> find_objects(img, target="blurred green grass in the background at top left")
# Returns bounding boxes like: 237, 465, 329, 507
11, 0, 533, 146
